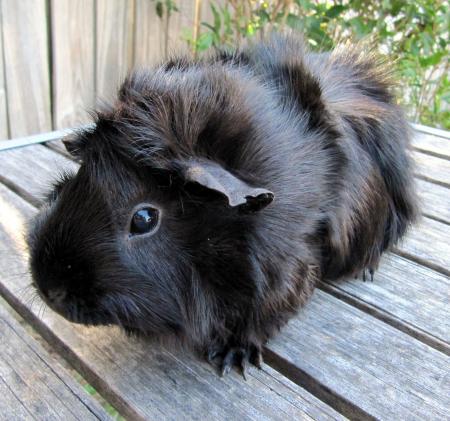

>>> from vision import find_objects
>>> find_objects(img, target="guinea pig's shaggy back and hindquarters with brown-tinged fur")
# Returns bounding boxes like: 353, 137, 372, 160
239, 37, 417, 279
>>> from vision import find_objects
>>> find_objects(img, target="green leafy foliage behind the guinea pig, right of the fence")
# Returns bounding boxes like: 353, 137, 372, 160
158, 0, 450, 129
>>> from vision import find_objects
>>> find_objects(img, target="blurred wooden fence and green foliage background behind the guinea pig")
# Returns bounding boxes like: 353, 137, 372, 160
0, 0, 450, 139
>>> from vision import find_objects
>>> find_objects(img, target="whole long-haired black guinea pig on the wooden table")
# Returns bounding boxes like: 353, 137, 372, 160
28, 36, 417, 373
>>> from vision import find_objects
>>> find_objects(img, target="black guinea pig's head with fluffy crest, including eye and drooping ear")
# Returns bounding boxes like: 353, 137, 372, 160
28, 64, 273, 334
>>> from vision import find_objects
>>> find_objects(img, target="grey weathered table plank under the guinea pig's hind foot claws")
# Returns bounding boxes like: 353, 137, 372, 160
326, 254, 450, 354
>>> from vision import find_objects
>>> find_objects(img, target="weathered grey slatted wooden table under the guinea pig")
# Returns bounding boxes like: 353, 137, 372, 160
0, 126, 450, 420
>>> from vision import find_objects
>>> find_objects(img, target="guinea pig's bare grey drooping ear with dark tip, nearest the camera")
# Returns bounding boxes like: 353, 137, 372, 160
177, 159, 274, 212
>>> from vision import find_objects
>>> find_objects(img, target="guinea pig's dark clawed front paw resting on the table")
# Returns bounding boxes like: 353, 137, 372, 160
207, 344, 263, 380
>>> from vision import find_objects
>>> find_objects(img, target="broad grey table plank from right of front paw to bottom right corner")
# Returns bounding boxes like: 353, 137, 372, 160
268, 290, 450, 420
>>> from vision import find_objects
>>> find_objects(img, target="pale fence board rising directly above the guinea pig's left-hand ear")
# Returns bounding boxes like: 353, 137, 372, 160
51, 0, 95, 129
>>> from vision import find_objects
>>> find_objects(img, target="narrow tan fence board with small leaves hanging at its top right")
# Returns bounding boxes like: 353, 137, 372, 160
134, 0, 164, 67
